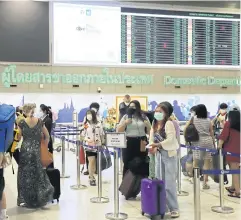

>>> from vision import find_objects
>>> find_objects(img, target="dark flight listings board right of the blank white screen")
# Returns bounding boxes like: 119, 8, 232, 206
121, 8, 240, 66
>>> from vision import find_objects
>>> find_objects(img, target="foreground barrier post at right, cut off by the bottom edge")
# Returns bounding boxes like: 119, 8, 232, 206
193, 168, 201, 220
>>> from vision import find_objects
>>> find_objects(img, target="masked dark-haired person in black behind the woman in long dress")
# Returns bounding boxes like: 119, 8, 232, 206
39, 104, 54, 168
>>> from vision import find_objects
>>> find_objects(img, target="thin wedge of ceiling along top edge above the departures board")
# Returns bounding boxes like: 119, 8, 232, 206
116, 0, 240, 9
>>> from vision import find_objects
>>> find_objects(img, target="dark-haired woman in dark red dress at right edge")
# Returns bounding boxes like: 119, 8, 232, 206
218, 110, 240, 198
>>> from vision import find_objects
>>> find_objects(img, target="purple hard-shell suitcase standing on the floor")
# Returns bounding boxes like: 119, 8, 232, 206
141, 179, 166, 219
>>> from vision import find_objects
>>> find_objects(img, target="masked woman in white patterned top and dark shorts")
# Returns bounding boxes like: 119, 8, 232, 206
81, 110, 105, 186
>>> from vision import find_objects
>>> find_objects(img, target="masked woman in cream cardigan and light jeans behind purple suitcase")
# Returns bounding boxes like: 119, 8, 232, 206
150, 102, 179, 218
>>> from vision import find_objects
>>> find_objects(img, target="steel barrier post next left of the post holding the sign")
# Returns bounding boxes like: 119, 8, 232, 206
90, 146, 109, 203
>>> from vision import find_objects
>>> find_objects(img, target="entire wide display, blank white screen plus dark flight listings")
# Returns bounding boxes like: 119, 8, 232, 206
53, 3, 240, 67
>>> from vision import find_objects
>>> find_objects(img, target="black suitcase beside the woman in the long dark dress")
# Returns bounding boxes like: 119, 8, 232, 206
46, 168, 61, 202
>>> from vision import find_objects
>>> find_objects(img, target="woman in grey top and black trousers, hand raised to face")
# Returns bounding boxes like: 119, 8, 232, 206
117, 100, 151, 176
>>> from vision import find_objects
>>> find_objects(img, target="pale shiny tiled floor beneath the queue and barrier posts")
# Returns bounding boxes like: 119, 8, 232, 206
5, 139, 241, 220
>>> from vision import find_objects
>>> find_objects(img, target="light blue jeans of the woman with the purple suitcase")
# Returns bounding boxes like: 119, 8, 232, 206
155, 149, 179, 212
